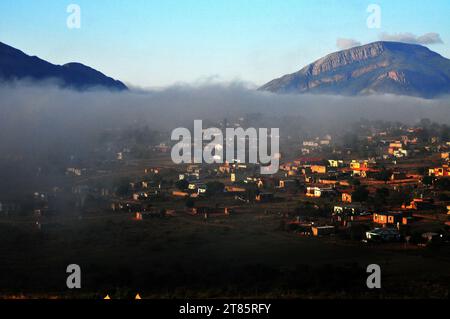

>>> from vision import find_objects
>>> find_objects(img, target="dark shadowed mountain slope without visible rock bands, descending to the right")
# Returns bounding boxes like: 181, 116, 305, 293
0, 42, 128, 91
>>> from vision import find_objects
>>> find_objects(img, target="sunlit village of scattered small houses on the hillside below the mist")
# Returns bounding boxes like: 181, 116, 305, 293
0, 118, 450, 300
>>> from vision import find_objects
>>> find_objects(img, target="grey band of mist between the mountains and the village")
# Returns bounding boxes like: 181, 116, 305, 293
0, 83, 450, 155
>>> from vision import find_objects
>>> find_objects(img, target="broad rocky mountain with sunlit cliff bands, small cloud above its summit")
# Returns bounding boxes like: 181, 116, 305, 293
259, 41, 450, 98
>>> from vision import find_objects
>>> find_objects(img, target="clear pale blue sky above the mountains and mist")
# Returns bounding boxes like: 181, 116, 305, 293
0, 0, 450, 87
